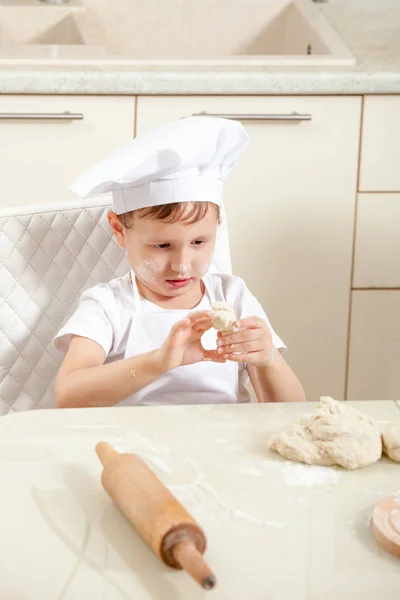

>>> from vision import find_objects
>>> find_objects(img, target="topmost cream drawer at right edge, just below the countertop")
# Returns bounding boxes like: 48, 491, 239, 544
359, 96, 400, 192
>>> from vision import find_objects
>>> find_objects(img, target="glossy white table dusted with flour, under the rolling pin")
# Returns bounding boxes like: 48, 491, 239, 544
0, 401, 400, 600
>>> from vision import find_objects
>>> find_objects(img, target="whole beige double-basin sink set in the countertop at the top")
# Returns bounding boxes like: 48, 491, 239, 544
0, 0, 355, 67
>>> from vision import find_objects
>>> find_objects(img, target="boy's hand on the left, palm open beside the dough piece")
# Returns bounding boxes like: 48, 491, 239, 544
156, 311, 226, 370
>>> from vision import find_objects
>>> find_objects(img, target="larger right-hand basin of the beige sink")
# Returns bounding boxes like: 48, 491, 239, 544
85, 0, 355, 66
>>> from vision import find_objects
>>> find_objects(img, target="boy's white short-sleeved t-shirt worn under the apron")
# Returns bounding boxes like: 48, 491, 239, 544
54, 272, 286, 404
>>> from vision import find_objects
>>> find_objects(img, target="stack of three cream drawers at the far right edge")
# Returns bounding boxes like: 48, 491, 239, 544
347, 96, 400, 400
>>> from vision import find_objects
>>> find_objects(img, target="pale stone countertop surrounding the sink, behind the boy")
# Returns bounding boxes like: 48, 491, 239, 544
0, 0, 400, 95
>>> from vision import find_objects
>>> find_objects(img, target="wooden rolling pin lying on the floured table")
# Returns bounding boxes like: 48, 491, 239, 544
96, 442, 216, 590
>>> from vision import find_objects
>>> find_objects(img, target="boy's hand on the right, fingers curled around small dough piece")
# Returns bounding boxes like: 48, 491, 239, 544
217, 317, 276, 367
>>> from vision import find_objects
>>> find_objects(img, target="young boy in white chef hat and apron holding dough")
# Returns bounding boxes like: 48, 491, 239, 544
54, 117, 305, 407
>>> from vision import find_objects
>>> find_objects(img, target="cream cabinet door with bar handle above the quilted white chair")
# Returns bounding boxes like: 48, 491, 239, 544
0, 96, 135, 208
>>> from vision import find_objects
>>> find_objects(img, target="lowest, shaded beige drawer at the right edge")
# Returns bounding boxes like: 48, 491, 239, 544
347, 290, 400, 400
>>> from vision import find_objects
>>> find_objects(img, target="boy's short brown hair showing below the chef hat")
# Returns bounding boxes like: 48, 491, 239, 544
119, 202, 221, 229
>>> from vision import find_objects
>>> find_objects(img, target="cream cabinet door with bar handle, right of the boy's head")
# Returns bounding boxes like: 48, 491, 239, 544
137, 96, 361, 400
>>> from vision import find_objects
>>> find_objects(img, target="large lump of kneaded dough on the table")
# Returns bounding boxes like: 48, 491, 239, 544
268, 397, 382, 469
